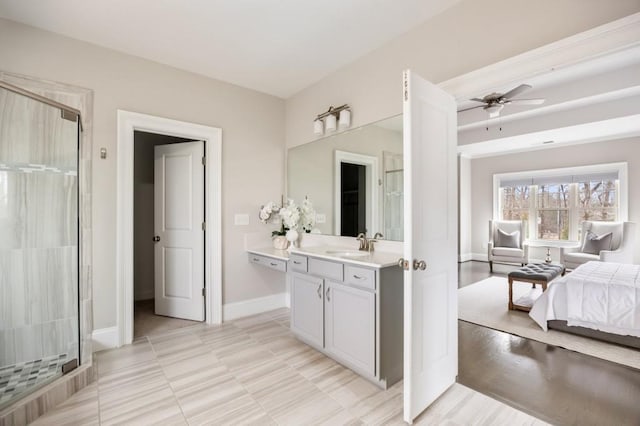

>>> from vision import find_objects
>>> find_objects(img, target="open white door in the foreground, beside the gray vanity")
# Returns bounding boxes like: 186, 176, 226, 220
403, 71, 458, 423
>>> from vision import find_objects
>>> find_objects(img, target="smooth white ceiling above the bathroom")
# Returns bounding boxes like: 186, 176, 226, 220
0, 0, 460, 98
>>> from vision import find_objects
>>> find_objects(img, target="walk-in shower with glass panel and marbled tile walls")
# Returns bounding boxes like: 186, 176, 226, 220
0, 82, 81, 409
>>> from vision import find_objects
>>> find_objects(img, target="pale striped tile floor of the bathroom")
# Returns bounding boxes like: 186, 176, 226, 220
35, 309, 544, 425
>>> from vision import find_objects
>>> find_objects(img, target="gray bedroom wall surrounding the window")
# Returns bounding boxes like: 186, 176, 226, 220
471, 137, 640, 263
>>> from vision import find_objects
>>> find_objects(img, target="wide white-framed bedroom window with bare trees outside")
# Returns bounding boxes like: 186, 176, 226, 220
494, 163, 627, 244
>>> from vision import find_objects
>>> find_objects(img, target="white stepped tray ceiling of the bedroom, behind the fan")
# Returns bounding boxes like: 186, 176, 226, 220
458, 43, 640, 158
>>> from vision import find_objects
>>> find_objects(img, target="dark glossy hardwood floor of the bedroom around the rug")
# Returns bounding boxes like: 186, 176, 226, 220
458, 262, 640, 425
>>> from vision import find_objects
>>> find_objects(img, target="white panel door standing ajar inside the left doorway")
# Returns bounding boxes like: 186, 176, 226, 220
154, 142, 204, 321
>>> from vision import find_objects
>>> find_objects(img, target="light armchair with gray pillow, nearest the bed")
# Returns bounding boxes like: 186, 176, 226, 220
560, 221, 636, 269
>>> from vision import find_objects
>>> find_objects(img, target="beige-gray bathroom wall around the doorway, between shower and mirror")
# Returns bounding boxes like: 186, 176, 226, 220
0, 19, 284, 329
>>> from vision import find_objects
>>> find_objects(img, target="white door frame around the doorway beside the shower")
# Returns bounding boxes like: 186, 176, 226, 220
116, 110, 222, 346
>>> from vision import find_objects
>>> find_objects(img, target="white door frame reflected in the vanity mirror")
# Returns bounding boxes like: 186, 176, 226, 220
333, 150, 382, 236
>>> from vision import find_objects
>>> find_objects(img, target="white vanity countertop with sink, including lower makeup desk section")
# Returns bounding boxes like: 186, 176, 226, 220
247, 246, 402, 268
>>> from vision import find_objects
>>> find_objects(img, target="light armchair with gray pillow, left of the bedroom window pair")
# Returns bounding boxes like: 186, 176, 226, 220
487, 220, 529, 272
